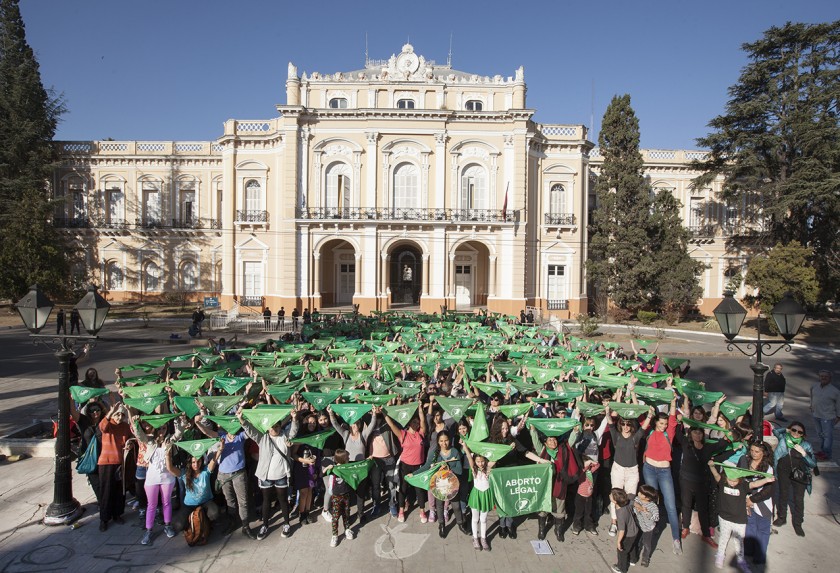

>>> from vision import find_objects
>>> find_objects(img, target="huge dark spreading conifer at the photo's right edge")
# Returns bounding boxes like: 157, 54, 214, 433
697, 20, 840, 297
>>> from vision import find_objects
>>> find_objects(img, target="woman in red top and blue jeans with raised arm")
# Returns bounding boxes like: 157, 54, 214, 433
642, 394, 682, 555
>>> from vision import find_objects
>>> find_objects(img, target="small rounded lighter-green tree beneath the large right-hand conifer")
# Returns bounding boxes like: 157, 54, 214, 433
745, 242, 819, 316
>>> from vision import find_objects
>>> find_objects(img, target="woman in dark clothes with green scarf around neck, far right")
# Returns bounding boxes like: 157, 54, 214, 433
773, 422, 817, 537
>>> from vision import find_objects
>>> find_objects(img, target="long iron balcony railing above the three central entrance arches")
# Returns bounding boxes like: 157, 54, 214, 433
296, 207, 519, 223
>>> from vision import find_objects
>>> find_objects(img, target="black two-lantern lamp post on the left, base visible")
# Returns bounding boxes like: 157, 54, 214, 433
15, 284, 111, 525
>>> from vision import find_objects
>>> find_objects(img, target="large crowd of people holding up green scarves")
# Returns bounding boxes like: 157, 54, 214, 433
71, 314, 840, 573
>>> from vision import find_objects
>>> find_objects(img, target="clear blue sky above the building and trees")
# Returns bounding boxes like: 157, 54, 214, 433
21, 0, 840, 149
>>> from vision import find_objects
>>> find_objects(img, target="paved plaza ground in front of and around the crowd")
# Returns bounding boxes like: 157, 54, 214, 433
0, 325, 840, 573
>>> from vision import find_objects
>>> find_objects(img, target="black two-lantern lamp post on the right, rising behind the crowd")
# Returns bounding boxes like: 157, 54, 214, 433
714, 291, 805, 438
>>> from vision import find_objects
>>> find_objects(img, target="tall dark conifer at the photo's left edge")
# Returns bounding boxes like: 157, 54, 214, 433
0, 0, 70, 299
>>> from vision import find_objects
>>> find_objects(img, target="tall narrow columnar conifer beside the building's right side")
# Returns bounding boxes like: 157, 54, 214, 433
586, 94, 656, 310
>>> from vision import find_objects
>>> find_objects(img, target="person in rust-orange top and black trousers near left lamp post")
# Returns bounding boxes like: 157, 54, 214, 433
99, 404, 131, 531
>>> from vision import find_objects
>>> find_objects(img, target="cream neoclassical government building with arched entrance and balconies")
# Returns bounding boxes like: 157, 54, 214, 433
53, 44, 760, 318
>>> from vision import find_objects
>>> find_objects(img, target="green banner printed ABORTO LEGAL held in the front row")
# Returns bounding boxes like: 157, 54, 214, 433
490, 464, 554, 517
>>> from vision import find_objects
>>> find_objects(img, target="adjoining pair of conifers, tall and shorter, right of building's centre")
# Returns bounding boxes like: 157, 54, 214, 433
586, 95, 702, 313
